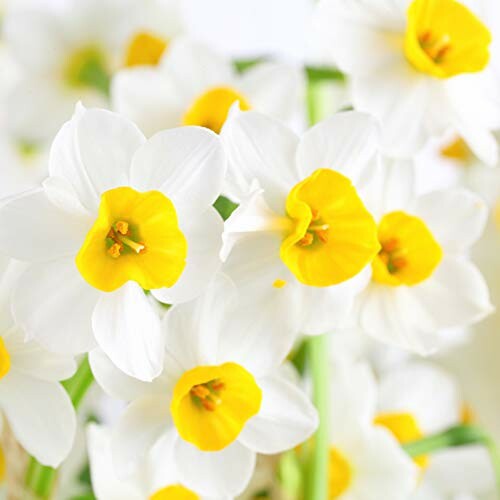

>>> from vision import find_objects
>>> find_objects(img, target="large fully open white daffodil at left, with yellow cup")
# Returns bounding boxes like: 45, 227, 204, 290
0, 103, 225, 380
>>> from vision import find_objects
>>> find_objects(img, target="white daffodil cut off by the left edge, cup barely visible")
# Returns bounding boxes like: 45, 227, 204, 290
0, 257, 76, 466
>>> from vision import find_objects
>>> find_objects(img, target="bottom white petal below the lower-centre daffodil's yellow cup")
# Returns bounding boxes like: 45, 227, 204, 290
174, 437, 255, 498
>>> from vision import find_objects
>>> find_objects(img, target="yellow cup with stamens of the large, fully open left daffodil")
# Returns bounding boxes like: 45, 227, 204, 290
76, 187, 187, 292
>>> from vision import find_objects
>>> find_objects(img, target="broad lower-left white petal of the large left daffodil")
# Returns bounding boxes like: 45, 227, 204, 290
12, 258, 99, 353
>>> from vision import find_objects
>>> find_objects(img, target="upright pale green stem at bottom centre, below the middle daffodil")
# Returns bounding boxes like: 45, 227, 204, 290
304, 335, 330, 500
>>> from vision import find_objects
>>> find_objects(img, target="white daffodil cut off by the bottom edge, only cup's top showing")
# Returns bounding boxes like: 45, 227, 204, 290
87, 424, 225, 500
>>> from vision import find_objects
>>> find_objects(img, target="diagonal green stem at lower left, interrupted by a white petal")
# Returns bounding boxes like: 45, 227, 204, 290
26, 356, 94, 500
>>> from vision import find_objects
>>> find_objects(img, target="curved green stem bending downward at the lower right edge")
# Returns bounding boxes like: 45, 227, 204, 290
403, 425, 500, 493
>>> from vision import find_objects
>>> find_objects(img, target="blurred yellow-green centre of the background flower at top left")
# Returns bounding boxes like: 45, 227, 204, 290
64, 46, 110, 94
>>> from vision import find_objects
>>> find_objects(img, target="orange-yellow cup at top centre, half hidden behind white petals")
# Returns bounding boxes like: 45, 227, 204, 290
182, 87, 250, 134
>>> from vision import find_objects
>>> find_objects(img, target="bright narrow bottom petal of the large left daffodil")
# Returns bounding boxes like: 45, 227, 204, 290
92, 281, 164, 382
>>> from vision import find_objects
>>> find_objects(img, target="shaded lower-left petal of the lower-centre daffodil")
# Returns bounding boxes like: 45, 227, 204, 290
111, 394, 172, 478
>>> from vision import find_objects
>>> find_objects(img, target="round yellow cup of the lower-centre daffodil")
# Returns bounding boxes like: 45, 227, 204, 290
170, 363, 262, 451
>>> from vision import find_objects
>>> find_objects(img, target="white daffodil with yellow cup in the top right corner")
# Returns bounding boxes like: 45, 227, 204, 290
314, 0, 500, 164
